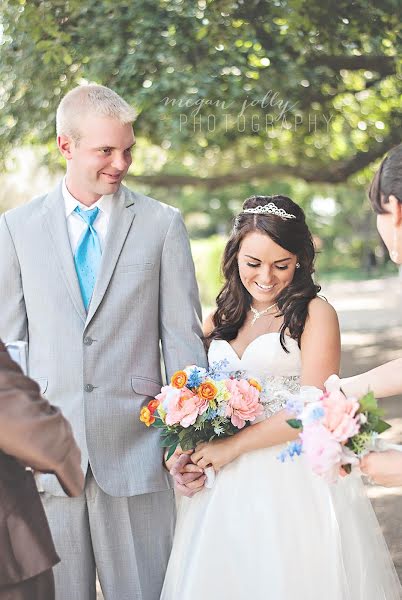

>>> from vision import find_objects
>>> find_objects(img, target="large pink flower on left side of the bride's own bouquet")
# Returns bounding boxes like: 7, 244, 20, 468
156, 385, 203, 427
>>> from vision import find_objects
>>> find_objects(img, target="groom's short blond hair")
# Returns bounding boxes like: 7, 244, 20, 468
56, 84, 136, 143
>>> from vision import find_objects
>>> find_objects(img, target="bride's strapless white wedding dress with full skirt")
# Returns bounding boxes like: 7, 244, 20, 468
161, 333, 401, 600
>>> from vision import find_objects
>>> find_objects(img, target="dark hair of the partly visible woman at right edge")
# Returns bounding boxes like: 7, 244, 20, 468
369, 144, 402, 215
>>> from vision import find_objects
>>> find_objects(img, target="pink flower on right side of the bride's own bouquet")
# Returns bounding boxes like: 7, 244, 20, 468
225, 379, 263, 429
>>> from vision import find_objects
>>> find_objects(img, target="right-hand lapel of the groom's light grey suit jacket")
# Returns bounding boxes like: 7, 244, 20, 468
85, 187, 135, 327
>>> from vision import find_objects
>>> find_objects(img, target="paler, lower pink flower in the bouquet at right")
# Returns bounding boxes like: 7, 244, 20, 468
300, 423, 343, 481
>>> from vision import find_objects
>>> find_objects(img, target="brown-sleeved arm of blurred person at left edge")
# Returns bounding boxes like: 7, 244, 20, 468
0, 341, 84, 496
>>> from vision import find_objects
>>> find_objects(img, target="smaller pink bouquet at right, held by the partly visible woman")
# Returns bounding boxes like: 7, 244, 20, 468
279, 375, 390, 482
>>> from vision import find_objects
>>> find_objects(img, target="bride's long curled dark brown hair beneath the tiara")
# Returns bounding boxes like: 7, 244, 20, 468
206, 196, 321, 352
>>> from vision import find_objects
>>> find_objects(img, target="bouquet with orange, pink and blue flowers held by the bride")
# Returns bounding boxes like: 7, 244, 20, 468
140, 361, 263, 458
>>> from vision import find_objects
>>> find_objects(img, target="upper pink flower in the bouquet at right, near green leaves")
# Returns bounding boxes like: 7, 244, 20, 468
322, 390, 359, 442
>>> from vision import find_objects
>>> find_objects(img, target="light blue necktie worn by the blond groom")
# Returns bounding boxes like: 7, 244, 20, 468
74, 206, 102, 310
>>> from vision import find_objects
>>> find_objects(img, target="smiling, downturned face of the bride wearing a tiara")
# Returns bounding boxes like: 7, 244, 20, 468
237, 231, 297, 310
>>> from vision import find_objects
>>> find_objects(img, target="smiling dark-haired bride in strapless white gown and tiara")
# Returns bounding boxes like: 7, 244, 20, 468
161, 196, 400, 600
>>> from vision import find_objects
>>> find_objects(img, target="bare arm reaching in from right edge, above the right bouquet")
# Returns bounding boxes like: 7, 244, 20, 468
341, 358, 402, 398
